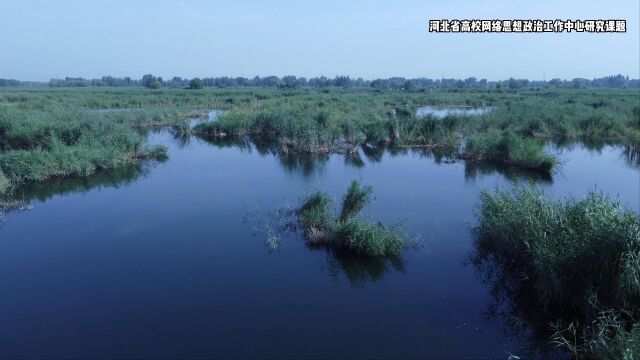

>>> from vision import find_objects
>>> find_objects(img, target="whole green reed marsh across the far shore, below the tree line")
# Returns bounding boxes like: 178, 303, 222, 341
0, 88, 640, 193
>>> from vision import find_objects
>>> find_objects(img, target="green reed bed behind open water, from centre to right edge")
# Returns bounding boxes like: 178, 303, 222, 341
195, 90, 640, 171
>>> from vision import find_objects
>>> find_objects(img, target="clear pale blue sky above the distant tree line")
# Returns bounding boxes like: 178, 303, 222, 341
0, 0, 640, 80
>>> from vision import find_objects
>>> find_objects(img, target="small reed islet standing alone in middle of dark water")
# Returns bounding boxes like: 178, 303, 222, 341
299, 181, 407, 256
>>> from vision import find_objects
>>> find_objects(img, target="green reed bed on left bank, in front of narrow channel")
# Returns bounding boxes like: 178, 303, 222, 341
0, 104, 173, 193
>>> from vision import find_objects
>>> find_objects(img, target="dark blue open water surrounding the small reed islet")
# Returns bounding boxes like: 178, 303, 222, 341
0, 130, 640, 358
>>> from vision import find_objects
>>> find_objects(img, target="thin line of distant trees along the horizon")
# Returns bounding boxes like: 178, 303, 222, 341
0, 74, 640, 91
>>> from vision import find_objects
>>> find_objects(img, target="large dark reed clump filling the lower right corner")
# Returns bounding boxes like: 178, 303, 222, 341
471, 187, 640, 359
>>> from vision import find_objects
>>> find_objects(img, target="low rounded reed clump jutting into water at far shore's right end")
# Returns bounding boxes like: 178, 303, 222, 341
462, 131, 557, 172
